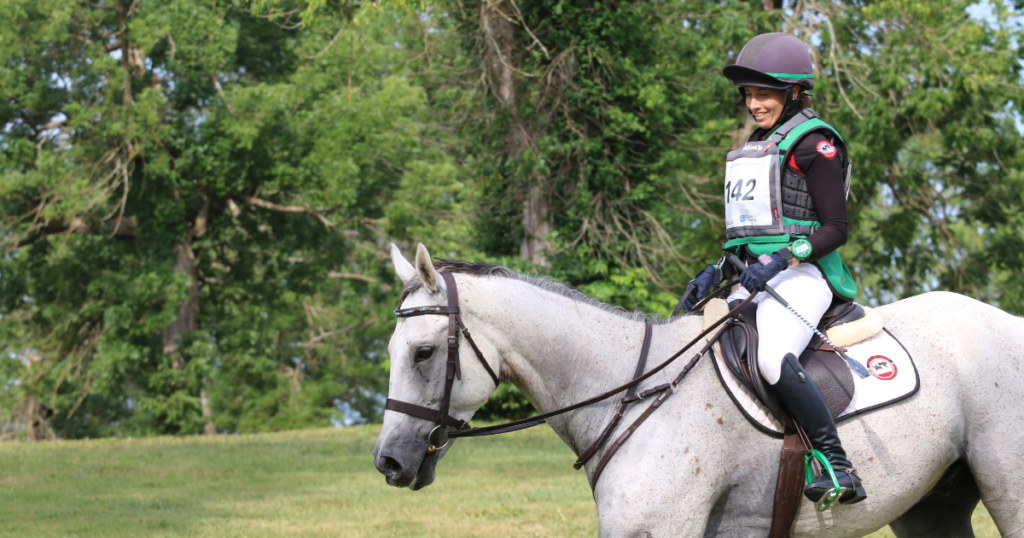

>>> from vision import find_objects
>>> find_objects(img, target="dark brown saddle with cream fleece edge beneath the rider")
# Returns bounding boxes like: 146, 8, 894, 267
705, 301, 883, 421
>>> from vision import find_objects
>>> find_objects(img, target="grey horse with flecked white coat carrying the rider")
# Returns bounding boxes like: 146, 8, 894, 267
374, 245, 1024, 538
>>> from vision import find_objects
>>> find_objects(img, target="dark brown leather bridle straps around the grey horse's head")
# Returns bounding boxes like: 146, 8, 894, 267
384, 273, 499, 453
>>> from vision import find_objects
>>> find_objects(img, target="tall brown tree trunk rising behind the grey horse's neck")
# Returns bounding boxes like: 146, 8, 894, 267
480, 0, 552, 266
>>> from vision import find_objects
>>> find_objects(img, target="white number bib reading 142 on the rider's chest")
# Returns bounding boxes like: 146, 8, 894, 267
724, 141, 782, 239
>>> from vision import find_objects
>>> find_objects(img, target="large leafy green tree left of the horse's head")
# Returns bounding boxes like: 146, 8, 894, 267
0, 1, 464, 437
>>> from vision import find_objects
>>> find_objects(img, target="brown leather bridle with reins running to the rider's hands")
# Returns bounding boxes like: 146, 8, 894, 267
384, 273, 757, 459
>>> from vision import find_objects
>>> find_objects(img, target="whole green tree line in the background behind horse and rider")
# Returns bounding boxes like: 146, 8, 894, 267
0, 0, 1024, 438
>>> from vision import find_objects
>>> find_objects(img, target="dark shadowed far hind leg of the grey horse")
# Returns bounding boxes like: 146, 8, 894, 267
889, 460, 981, 538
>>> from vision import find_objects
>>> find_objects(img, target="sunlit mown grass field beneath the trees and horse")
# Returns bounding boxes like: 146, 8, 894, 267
0, 426, 998, 538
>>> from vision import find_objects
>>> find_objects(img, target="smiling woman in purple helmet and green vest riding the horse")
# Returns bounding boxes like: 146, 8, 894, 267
684, 33, 866, 504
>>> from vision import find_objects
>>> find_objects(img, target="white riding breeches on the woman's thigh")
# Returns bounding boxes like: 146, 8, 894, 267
728, 263, 833, 384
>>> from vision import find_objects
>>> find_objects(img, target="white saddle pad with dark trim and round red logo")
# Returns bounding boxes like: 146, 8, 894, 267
708, 329, 921, 439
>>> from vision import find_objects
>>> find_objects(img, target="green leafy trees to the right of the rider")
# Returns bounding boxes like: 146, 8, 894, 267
805, 0, 1024, 313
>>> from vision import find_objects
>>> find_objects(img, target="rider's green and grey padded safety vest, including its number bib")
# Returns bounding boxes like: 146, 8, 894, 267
722, 109, 857, 299
